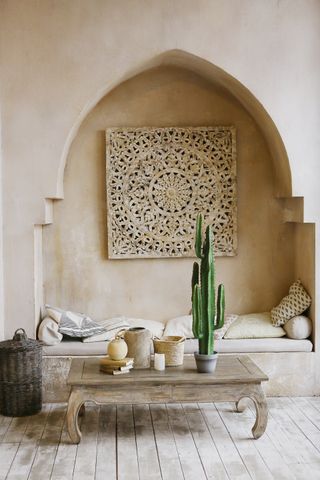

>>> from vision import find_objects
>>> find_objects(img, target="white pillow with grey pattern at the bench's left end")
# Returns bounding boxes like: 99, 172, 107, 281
46, 305, 105, 338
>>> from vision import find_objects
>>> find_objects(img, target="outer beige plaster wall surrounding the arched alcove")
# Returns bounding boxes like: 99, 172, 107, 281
0, 0, 320, 337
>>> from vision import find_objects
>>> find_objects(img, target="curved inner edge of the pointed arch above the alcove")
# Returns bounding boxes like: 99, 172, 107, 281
55, 49, 292, 199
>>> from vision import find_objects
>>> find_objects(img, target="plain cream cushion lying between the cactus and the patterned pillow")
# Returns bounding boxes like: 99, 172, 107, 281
224, 312, 286, 339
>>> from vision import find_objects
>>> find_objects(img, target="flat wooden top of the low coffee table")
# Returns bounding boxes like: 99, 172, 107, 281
67, 355, 268, 386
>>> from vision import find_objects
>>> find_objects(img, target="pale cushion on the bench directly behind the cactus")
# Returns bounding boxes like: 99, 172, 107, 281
164, 314, 238, 340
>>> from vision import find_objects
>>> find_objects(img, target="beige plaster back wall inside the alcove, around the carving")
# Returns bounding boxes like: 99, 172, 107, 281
43, 67, 294, 320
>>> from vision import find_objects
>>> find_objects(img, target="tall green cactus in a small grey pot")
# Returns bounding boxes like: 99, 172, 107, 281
192, 214, 225, 373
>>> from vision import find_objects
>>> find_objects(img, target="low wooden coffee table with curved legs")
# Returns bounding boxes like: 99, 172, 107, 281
67, 355, 268, 443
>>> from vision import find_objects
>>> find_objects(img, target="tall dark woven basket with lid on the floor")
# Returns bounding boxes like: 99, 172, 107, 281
0, 328, 42, 417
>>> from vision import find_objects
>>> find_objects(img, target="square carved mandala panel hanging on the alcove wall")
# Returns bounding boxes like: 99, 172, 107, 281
106, 127, 237, 258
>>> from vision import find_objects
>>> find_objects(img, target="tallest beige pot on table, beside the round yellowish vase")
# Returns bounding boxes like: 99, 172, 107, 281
124, 327, 152, 368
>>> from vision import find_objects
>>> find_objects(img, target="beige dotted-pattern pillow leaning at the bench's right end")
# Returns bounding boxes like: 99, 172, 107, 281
271, 280, 311, 327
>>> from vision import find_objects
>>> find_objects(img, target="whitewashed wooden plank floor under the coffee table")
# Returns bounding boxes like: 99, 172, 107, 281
0, 397, 320, 480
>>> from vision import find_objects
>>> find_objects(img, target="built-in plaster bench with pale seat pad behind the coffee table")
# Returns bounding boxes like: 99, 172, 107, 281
43, 337, 318, 402
